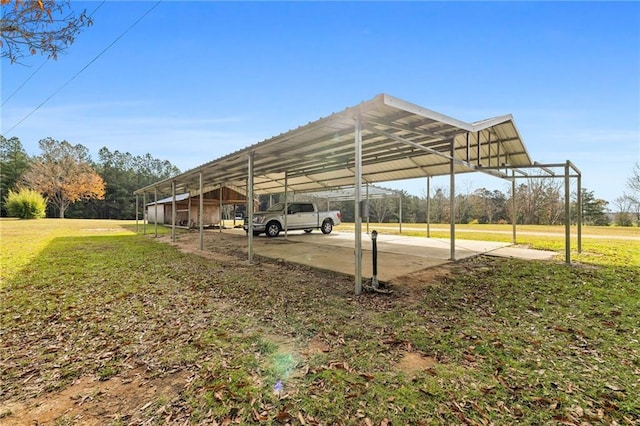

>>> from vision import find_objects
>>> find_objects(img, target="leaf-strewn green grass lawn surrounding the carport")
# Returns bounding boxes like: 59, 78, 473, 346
0, 220, 640, 425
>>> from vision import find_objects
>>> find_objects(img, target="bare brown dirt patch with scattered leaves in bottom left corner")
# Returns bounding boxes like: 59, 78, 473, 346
0, 369, 190, 426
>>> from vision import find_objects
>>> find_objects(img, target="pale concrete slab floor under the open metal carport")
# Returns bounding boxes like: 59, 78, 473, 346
242, 230, 555, 282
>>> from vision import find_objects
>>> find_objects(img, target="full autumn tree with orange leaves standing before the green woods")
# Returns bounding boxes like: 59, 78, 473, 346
22, 138, 105, 218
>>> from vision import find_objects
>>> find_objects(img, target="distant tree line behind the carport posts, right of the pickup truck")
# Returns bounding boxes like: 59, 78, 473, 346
297, 165, 640, 226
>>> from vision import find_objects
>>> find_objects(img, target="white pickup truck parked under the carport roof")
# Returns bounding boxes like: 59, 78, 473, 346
244, 202, 342, 237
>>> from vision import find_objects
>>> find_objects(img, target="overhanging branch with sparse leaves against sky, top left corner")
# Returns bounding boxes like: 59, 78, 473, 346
0, 0, 93, 63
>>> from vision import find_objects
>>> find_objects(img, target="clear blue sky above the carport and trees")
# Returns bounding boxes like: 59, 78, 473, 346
1, 1, 640, 207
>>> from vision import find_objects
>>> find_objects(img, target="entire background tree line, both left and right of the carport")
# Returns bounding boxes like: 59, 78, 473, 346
5, 135, 640, 226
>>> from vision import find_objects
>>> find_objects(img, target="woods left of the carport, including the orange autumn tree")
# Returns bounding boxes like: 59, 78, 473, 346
0, 135, 180, 219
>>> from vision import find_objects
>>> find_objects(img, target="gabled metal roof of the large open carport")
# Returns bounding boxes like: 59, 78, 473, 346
135, 94, 532, 194
